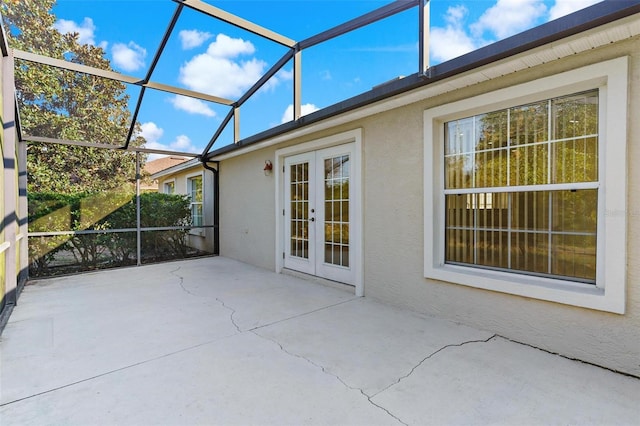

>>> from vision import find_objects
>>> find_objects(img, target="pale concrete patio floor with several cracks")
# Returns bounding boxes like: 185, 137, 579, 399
0, 257, 640, 426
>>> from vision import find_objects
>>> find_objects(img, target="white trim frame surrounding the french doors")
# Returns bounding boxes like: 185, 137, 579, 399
275, 128, 364, 296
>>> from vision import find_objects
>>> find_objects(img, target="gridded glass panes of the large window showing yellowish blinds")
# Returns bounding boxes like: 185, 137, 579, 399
444, 90, 598, 284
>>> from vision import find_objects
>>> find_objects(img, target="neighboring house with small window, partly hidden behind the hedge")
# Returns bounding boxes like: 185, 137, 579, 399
151, 159, 214, 253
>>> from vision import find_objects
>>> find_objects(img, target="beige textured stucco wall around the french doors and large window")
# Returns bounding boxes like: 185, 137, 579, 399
220, 38, 640, 376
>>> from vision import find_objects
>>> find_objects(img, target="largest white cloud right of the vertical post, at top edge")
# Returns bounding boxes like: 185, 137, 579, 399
471, 0, 547, 39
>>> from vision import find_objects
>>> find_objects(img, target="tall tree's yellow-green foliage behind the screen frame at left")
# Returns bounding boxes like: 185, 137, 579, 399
1, 0, 144, 193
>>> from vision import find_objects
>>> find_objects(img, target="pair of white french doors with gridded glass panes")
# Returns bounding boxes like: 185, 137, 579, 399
284, 144, 355, 285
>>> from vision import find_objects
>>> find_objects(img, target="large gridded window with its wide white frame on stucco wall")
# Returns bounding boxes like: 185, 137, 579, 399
424, 57, 628, 313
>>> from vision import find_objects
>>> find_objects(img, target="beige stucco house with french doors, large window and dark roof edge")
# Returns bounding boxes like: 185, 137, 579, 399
208, 2, 640, 376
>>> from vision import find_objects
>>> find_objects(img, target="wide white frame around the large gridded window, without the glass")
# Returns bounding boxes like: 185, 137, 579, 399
424, 57, 628, 314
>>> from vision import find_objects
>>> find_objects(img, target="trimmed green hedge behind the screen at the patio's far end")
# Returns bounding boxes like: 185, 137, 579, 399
27, 191, 191, 276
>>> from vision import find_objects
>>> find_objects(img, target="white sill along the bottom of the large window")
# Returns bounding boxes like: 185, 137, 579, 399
425, 264, 625, 314
